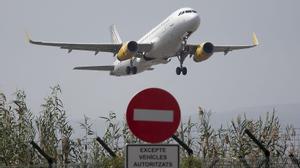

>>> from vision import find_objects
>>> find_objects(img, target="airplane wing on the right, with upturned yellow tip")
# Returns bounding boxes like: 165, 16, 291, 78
187, 33, 259, 55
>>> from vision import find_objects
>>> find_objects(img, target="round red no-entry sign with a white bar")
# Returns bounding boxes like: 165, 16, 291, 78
126, 88, 180, 143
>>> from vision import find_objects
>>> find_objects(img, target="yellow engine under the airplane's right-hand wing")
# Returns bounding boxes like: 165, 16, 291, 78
194, 42, 214, 62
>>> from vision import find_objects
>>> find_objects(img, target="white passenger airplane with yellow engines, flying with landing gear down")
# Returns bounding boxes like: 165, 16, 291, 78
27, 7, 259, 76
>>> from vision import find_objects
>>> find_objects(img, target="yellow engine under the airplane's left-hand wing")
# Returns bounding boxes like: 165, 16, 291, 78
117, 41, 138, 61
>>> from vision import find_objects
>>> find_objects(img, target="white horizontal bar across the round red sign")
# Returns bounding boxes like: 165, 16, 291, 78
133, 109, 174, 122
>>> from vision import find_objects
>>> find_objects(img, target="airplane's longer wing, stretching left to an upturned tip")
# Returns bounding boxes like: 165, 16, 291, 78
26, 34, 152, 55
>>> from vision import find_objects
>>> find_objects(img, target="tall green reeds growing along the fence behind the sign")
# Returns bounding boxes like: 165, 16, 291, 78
0, 86, 300, 168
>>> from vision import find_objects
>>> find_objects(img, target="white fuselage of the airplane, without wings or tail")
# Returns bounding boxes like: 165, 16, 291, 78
111, 8, 200, 76
